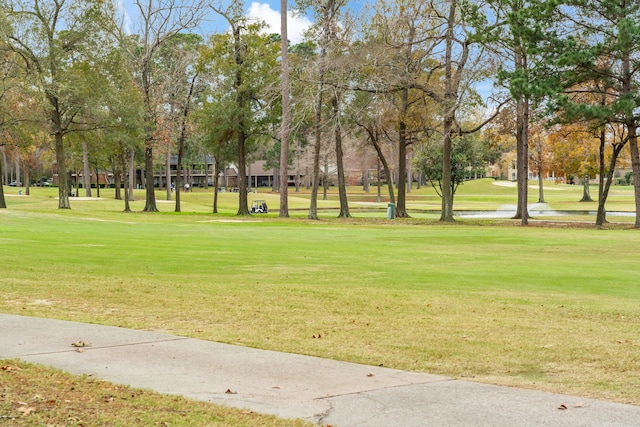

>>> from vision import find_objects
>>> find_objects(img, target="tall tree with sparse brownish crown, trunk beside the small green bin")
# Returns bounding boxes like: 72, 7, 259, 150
357, 0, 442, 217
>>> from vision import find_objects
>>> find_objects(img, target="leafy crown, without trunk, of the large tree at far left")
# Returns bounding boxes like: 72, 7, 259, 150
0, 0, 113, 133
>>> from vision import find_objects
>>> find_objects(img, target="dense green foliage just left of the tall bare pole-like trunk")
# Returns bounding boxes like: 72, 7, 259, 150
198, 14, 281, 165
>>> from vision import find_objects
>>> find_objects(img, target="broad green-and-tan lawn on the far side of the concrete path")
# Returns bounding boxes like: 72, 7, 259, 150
0, 181, 640, 422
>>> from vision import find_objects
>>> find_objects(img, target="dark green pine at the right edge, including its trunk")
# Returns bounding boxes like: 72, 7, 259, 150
535, 0, 640, 228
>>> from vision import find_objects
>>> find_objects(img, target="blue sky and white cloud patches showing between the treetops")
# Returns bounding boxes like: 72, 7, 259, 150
118, 0, 311, 45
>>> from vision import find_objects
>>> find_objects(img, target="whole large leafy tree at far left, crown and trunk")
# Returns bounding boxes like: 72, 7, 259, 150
0, 0, 113, 209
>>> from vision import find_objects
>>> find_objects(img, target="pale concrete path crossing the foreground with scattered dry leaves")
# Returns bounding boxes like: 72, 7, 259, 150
0, 314, 640, 427
